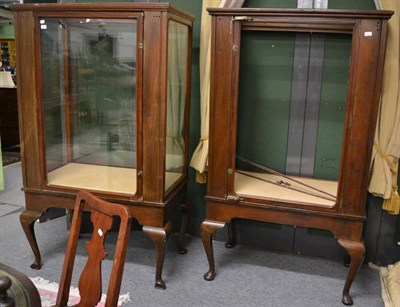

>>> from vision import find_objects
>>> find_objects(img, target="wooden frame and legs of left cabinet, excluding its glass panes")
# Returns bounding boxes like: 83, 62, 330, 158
11, 3, 194, 288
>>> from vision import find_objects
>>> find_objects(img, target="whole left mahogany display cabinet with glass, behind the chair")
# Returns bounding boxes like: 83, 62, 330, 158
11, 3, 194, 288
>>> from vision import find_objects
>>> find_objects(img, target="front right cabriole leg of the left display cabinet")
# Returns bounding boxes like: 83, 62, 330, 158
143, 222, 172, 289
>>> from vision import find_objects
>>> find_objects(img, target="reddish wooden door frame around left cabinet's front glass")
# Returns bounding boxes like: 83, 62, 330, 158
33, 11, 144, 201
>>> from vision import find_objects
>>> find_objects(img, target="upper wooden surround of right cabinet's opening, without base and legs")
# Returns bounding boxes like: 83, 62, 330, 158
207, 9, 391, 218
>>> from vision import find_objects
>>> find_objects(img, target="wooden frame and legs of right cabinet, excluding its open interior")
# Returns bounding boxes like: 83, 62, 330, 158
201, 8, 393, 305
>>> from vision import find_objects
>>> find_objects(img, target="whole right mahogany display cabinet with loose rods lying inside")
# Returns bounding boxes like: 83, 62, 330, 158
201, 8, 393, 305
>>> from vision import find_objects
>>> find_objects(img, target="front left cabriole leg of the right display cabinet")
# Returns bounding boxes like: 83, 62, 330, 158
201, 220, 225, 280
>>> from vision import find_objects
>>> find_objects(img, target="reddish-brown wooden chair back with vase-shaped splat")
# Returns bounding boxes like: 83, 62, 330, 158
56, 191, 131, 307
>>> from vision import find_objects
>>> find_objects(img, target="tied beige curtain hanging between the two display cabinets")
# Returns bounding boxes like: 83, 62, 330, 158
190, 0, 245, 183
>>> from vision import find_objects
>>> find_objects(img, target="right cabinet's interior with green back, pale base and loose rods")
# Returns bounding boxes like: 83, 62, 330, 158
234, 31, 351, 207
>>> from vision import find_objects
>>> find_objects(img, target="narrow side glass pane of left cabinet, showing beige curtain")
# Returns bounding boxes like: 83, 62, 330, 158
165, 21, 189, 190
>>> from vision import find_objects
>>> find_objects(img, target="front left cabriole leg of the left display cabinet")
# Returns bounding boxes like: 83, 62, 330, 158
19, 210, 43, 270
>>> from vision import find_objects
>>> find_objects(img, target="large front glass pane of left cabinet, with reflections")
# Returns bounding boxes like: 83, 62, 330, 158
39, 18, 136, 194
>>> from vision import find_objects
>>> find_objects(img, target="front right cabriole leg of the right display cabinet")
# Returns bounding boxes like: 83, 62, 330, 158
338, 239, 365, 306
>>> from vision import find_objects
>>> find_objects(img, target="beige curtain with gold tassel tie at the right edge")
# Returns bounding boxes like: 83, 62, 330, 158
368, 0, 400, 214
